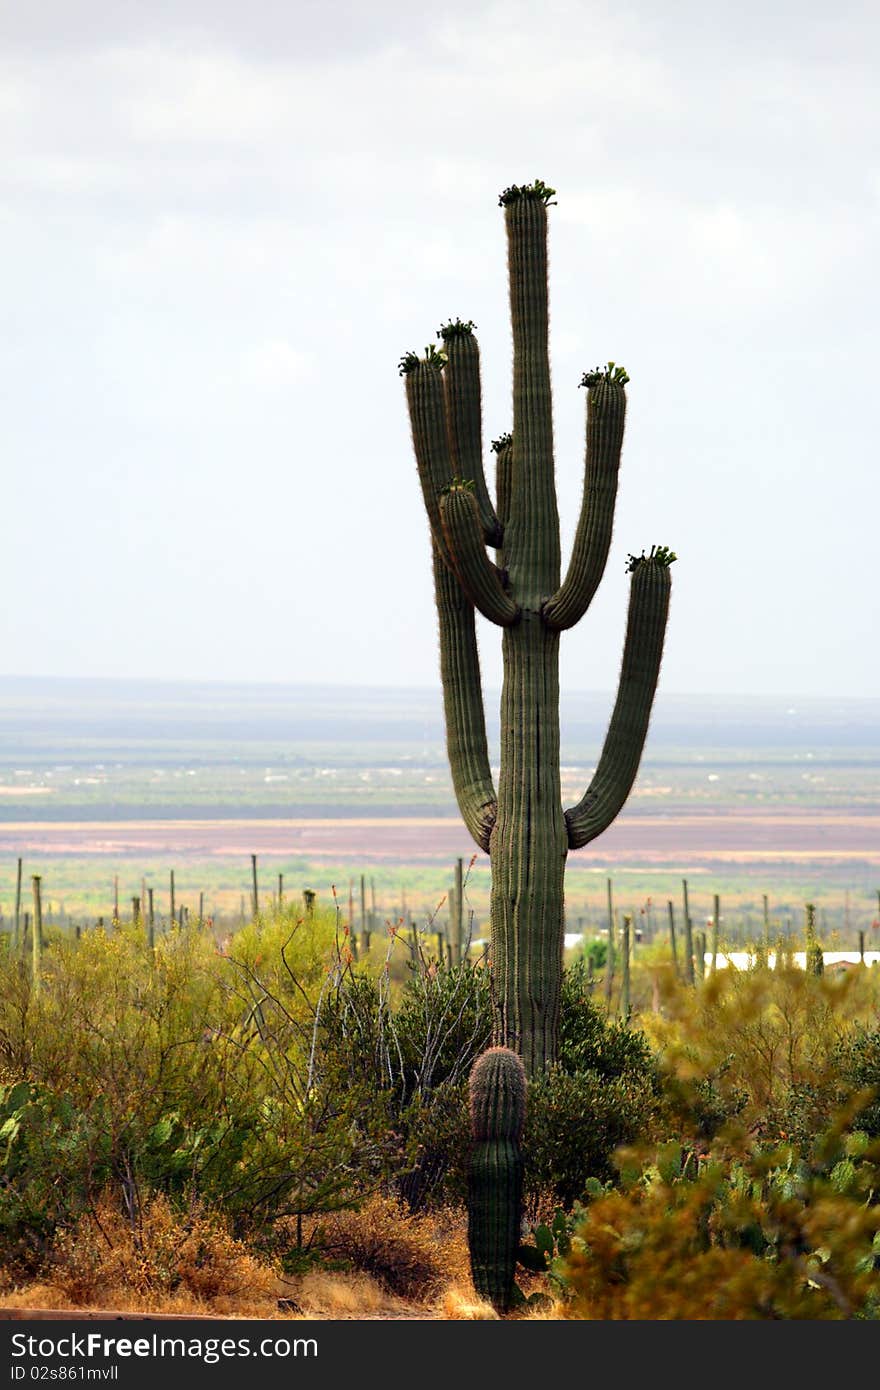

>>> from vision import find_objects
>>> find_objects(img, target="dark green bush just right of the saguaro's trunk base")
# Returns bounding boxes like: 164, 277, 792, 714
523, 1068, 658, 1218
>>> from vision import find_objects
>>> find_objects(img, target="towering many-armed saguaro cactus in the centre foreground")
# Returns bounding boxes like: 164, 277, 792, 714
400, 181, 674, 1073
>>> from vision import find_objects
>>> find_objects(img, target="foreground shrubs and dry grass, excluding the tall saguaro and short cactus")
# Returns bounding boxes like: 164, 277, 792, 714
0, 909, 880, 1318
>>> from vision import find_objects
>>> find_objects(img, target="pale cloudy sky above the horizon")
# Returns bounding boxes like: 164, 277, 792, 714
0, 0, 880, 695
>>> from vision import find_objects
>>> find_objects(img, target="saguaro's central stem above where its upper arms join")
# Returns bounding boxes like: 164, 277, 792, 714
500, 188, 560, 609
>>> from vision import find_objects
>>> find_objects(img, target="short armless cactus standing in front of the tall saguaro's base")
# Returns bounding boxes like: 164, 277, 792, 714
467, 1047, 525, 1312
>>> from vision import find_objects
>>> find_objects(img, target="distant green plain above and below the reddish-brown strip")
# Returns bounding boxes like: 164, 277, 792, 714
0, 678, 880, 941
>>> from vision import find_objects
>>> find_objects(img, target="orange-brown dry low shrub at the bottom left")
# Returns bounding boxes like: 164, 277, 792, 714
49, 1193, 277, 1305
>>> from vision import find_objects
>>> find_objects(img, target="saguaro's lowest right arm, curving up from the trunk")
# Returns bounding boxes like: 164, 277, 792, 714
566, 559, 670, 849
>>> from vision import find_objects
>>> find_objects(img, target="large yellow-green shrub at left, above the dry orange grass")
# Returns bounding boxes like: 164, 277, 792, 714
0, 923, 394, 1254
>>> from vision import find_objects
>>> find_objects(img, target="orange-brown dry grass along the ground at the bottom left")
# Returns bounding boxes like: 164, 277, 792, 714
3, 1195, 559, 1322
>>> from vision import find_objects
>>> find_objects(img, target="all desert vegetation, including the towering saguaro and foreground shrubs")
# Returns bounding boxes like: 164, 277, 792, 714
0, 179, 880, 1321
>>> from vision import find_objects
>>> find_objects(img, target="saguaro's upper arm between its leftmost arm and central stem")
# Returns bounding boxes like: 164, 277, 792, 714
438, 318, 502, 546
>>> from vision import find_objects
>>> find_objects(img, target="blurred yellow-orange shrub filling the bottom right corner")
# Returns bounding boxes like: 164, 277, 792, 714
553, 1127, 880, 1321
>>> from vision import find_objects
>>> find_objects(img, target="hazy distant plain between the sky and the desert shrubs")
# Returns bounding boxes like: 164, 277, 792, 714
0, 678, 880, 930
